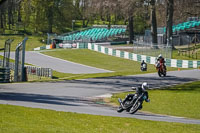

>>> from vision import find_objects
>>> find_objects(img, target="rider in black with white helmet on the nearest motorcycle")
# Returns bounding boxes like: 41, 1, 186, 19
120, 82, 150, 109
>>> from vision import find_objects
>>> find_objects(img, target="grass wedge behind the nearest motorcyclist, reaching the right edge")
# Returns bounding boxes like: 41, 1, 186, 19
111, 81, 200, 119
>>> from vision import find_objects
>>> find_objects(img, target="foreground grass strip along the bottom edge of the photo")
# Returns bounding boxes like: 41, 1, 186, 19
0, 105, 200, 133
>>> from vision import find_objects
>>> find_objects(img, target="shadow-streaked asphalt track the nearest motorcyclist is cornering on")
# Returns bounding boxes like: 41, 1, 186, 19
0, 70, 200, 124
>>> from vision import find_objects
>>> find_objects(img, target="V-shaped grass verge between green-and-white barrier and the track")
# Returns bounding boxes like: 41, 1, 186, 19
42, 49, 180, 79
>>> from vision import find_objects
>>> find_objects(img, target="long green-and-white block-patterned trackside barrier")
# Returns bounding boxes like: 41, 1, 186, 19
34, 43, 200, 68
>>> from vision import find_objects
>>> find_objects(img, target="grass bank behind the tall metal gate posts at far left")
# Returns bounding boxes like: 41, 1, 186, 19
0, 36, 45, 52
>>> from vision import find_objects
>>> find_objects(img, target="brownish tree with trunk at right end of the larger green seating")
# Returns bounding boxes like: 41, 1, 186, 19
88, 0, 147, 43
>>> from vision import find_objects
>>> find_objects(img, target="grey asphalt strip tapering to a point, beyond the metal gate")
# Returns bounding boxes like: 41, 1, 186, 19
0, 51, 112, 74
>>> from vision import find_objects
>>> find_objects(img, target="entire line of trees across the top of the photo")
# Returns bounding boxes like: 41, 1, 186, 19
0, 0, 200, 43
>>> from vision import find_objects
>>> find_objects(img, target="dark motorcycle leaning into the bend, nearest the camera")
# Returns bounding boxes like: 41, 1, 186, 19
117, 88, 149, 114
